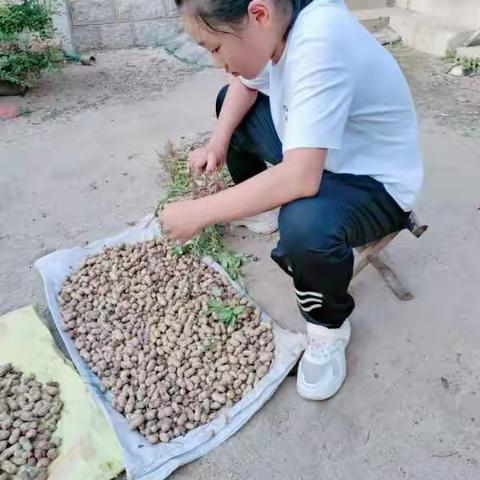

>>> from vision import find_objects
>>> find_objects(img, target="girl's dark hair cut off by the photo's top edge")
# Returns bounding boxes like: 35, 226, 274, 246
175, 0, 312, 30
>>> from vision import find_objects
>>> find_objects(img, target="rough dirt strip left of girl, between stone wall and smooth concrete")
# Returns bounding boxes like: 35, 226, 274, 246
0, 48, 200, 126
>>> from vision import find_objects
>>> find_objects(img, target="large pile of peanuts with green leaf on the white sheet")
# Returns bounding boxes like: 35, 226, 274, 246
58, 238, 275, 444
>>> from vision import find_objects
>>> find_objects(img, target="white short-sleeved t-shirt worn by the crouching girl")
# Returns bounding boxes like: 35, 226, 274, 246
242, 0, 423, 211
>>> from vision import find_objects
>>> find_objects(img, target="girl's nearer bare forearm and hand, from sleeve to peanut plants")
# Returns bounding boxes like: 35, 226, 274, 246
160, 148, 327, 241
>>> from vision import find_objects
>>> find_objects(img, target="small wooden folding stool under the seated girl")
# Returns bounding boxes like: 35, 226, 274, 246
353, 212, 428, 301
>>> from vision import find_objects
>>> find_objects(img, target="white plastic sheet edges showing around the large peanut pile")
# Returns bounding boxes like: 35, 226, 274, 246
35, 216, 305, 480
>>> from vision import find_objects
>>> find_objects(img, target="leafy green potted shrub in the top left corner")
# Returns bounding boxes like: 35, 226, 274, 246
0, 0, 63, 95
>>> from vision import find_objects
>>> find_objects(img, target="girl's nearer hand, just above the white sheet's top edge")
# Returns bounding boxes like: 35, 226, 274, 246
160, 200, 206, 243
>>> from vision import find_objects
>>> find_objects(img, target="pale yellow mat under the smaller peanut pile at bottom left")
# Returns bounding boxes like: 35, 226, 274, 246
0, 307, 123, 480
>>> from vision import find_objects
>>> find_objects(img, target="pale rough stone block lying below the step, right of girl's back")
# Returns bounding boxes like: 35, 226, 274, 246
390, 7, 472, 57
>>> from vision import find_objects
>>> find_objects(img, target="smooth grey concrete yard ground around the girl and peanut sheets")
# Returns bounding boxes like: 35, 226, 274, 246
0, 47, 480, 480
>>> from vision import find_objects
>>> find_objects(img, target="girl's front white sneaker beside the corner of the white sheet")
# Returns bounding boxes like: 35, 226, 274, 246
297, 320, 351, 400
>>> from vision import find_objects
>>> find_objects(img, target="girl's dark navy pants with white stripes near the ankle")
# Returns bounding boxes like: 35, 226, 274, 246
217, 87, 408, 328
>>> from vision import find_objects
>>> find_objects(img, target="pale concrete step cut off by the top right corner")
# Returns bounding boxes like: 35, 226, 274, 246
396, 0, 480, 28
